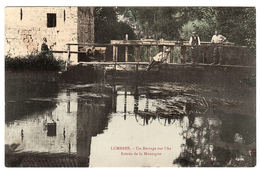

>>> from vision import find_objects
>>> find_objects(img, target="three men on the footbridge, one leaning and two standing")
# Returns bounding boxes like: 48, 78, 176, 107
147, 30, 227, 70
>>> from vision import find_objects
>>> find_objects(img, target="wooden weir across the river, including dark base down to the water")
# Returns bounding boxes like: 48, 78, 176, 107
52, 35, 256, 81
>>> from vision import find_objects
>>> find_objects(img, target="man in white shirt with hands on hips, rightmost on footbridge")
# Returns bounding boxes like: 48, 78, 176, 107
211, 30, 227, 65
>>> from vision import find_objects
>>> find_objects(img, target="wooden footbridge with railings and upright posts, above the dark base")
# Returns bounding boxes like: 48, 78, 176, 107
52, 35, 255, 70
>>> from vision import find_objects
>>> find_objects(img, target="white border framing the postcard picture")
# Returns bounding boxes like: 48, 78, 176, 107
0, 0, 260, 172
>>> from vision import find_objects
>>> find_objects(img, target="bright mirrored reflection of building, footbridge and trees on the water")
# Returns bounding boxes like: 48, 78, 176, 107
5, 78, 255, 167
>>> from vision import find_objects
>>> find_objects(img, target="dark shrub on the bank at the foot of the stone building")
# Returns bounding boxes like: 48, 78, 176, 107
5, 53, 65, 71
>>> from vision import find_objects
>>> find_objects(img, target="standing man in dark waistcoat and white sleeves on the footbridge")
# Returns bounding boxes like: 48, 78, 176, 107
189, 32, 200, 64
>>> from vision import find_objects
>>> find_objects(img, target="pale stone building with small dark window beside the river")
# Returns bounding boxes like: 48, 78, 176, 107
5, 7, 94, 63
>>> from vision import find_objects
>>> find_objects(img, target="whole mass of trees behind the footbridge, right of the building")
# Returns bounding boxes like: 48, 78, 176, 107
95, 7, 256, 49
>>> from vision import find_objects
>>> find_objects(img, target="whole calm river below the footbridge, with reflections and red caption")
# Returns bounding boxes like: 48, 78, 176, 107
5, 70, 256, 167
